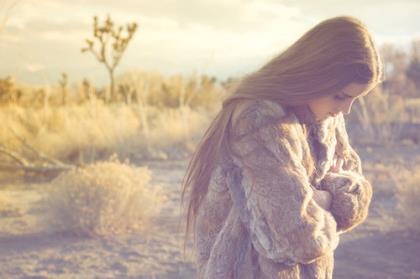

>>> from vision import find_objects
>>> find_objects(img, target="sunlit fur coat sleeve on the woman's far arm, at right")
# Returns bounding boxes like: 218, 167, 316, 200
320, 115, 373, 234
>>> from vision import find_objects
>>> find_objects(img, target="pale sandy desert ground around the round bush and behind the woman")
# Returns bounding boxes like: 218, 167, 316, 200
0, 146, 420, 279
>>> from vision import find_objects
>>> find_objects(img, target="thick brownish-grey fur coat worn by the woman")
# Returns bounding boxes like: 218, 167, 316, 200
195, 100, 372, 279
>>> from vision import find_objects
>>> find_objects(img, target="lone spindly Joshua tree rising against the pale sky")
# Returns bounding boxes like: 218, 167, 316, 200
82, 15, 137, 101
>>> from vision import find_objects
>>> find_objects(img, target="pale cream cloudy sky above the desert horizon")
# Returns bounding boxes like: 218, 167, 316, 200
0, 0, 420, 84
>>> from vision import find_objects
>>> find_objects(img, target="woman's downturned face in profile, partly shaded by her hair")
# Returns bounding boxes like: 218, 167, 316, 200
308, 83, 375, 121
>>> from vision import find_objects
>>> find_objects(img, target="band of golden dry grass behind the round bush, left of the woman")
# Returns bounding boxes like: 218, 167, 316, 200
0, 101, 220, 163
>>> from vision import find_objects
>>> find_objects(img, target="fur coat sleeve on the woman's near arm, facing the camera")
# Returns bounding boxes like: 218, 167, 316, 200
230, 104, 339, 265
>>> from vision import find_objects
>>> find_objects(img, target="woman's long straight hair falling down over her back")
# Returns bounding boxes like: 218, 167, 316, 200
181, 16, 382, 249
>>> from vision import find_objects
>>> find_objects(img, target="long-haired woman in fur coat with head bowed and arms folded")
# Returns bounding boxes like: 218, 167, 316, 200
182, 16, 382, 279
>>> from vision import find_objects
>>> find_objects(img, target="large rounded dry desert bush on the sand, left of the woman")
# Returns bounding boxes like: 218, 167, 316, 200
45, 160, 166, 236
